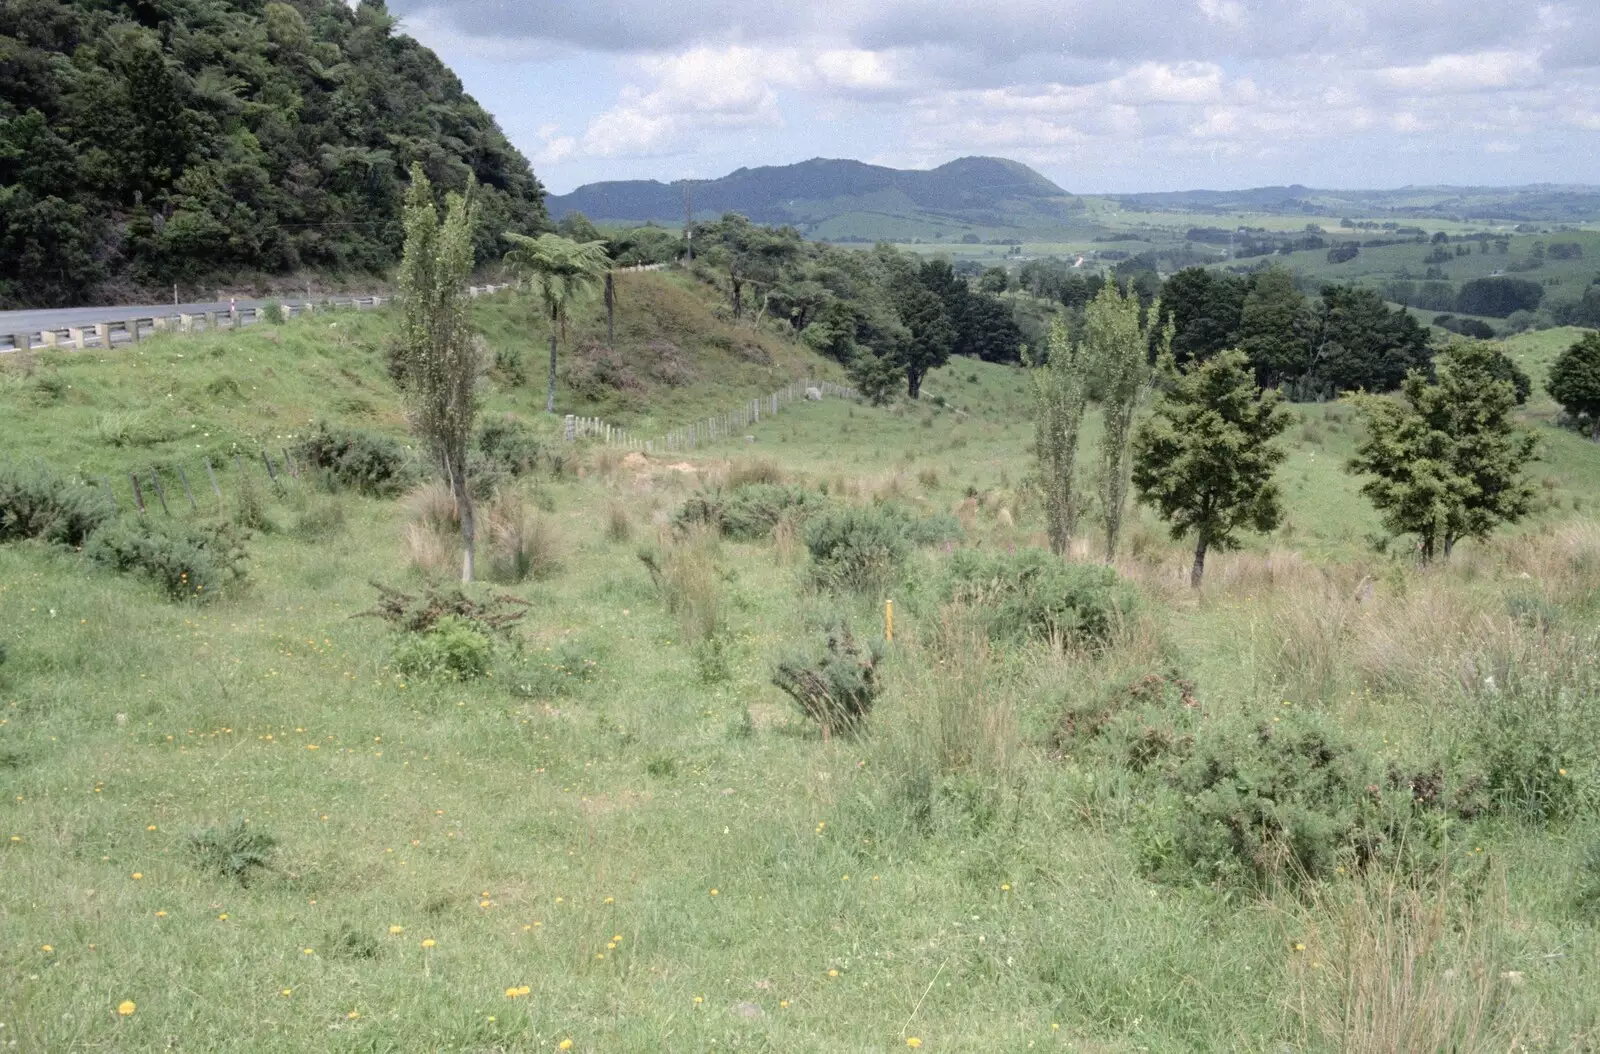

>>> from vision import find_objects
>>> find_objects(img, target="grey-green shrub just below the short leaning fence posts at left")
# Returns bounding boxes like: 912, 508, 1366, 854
85, 517, 248, 600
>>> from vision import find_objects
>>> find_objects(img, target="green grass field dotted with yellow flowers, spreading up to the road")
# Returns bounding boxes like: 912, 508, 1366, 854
0, 286, 1600, 1052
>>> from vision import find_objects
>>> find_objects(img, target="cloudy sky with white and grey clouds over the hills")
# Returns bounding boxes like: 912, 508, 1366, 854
389, 0, 1600, 194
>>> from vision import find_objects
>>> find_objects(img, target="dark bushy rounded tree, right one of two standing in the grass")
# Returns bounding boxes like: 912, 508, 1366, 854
1347, 342, 1538, 560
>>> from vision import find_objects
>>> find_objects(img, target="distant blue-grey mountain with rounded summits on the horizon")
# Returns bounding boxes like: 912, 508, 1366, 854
546, 157, 1083, 240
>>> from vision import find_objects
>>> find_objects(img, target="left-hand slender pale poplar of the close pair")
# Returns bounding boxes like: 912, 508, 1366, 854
1032, 318, 1088, 557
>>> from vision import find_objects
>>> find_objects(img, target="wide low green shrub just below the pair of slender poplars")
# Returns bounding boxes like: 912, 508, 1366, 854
941, 549, 1136, 646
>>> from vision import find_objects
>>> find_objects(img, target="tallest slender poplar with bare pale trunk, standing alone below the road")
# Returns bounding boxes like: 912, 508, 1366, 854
398, 165, 480, 582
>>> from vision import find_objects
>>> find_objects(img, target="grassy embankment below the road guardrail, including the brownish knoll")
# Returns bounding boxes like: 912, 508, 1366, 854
0, 272, 842, 478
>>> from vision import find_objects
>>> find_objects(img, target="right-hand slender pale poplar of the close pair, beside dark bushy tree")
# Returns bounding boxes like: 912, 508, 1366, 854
1082, 281, 1173, 560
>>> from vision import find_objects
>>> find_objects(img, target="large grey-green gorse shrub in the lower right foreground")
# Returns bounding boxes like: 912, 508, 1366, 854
1170, 710, 1411, 886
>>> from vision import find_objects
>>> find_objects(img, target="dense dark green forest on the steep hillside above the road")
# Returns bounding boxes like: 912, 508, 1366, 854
0, 0, 546, 307
